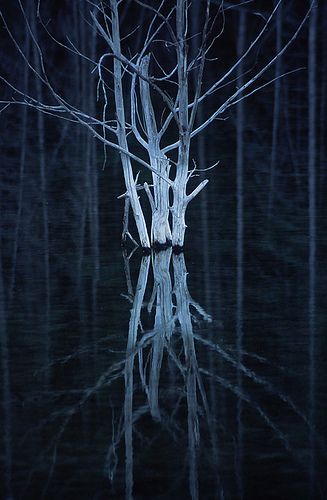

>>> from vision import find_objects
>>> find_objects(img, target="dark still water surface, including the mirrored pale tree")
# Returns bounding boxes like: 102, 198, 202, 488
0, 170, 327, 499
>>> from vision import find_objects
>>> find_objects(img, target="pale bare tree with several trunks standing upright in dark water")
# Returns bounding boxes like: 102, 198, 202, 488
2, 0, 313, 248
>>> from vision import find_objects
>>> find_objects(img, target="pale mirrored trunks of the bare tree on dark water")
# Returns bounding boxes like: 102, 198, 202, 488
116, 249, 211, 499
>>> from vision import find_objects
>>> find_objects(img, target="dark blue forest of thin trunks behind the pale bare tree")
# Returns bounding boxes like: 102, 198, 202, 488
0, 1, 327, 280
